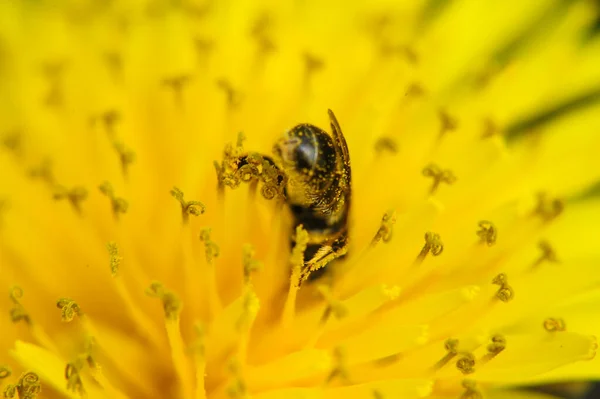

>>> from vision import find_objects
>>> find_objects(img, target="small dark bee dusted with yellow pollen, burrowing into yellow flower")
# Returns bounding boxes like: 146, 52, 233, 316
215, 110, 352, 281
